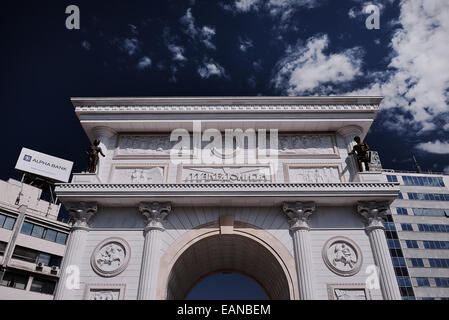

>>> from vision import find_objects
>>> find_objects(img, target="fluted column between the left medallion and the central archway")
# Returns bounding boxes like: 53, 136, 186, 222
137, 202, 171, 300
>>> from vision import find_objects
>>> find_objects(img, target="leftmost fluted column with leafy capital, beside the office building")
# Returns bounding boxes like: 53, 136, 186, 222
55, 202, 98, 300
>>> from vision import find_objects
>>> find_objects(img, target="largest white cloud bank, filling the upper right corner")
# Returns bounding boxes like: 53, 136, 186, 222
349, 0, 449, 131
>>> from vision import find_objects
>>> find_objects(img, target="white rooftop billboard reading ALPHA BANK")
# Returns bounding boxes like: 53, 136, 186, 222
16, 148, 73, 182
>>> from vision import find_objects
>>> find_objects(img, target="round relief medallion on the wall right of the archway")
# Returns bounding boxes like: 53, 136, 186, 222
322, 237, 363, 277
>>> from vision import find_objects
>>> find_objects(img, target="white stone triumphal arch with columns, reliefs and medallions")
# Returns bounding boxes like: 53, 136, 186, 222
55, 97, 400, 300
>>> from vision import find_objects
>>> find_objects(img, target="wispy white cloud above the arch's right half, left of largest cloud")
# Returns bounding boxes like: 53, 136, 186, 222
274, 35, 362, 95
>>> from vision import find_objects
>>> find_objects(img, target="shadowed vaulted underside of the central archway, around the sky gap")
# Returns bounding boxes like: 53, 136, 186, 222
167, 234, 290, 300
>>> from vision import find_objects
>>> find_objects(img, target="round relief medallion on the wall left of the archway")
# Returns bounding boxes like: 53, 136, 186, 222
90, 238, 131, 277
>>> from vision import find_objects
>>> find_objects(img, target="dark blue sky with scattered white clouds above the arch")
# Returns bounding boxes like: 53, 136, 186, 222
0, 0, 449, 297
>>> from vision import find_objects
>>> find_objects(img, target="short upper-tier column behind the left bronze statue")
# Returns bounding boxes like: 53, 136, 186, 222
92, 127, 117, 183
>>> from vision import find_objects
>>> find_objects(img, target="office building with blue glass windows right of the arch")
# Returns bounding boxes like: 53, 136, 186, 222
384, 172, 449, 300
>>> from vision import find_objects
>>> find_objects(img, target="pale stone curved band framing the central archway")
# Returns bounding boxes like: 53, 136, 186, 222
156, 221, 299, 300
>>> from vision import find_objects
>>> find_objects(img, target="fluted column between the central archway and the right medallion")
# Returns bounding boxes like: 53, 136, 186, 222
282, 202, 316, 300
